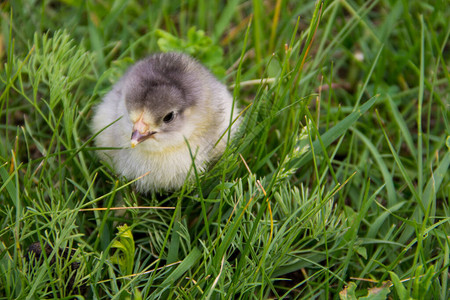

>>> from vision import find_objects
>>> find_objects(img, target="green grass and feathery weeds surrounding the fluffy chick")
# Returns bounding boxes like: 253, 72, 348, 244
0, 0, 450, 299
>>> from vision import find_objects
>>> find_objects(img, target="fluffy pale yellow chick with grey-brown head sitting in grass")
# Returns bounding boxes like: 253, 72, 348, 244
92, 53, 237, 193
